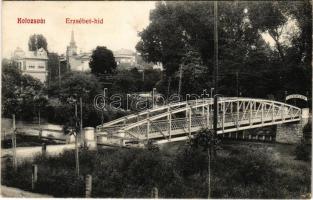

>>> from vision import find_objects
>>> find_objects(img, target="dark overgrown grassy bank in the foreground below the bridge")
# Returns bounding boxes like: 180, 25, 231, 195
2, 143, 311, 198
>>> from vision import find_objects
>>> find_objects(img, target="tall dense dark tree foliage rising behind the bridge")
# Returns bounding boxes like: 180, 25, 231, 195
136, 0, 312, 100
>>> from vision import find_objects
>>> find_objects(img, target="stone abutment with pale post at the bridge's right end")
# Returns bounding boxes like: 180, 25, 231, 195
276, 108, 310, 144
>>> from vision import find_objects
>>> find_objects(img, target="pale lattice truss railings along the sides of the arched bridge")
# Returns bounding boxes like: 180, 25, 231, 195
98, 98, 301, 139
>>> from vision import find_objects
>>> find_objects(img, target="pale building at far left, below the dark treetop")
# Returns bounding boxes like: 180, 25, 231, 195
12, 47, 48, 83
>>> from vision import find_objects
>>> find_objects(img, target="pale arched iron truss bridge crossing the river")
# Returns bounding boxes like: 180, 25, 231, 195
96, 97, 301, 146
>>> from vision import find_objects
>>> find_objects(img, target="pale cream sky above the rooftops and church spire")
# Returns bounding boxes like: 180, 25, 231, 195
2, 1, 155, 58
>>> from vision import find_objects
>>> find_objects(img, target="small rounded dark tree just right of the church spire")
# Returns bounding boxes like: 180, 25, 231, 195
89, 46, 117, 76
